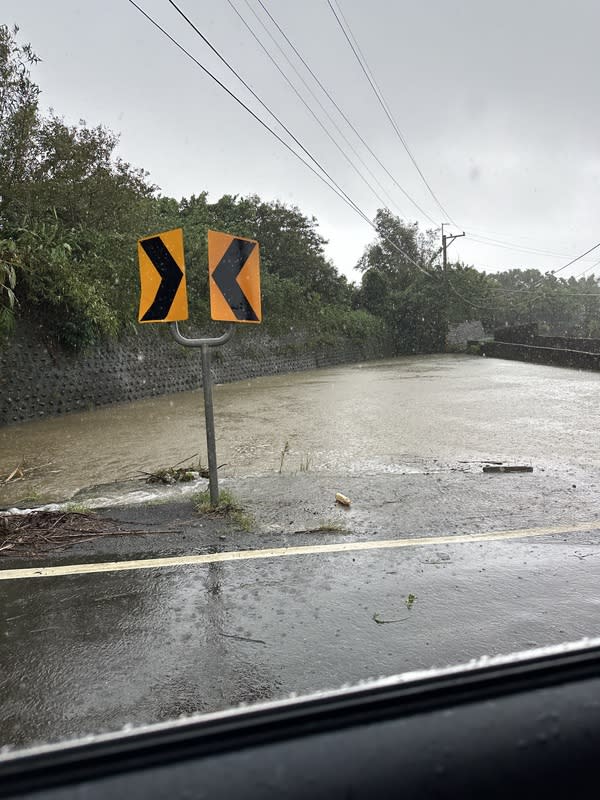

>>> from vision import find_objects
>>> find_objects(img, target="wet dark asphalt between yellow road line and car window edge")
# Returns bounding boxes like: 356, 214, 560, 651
0, 512, 600, 745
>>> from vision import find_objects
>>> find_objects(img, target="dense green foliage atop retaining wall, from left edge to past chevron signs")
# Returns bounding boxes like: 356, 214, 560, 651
0, 26, 379, 349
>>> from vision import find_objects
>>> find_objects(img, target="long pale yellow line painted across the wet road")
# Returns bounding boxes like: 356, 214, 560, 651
0, 520, 600, 581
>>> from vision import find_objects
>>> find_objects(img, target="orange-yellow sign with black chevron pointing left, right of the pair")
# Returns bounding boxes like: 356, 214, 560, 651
208, 231, 262, 323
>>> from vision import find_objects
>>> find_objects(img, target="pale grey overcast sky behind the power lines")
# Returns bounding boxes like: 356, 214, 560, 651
1, 0, 600, 278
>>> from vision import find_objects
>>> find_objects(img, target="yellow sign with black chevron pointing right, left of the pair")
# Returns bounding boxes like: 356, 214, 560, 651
138, 228, 188, 322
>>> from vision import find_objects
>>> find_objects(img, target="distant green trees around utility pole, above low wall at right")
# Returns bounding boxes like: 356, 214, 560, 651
355, 210, 600, 352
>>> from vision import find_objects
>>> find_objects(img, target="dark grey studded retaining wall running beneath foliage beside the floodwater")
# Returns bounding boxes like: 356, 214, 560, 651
0, 323, 389, 425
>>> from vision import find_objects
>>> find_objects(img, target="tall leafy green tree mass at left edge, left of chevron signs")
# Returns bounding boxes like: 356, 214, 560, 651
0, 26, 164, 348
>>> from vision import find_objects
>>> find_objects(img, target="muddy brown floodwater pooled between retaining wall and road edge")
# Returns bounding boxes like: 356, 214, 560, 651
0, 355, 600, 506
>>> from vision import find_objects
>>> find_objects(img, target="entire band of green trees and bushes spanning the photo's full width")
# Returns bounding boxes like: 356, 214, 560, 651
0, 26, 600, 352
